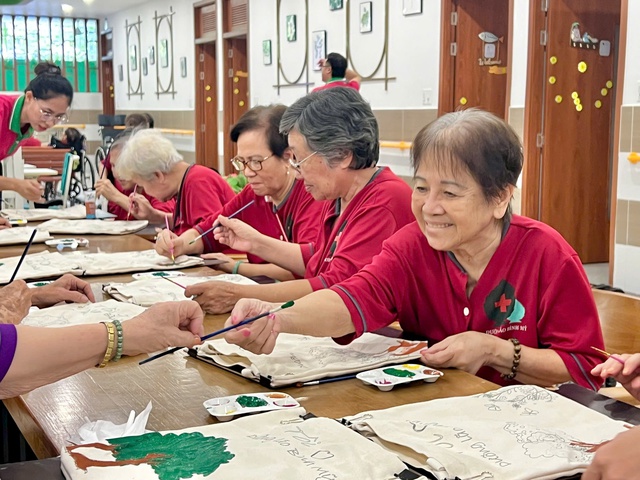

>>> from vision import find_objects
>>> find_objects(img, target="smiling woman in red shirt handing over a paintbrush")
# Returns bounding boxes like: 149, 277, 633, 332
226, 109, 603, 389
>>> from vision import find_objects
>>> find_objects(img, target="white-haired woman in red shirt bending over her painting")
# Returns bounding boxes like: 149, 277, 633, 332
115, 129, 234, 235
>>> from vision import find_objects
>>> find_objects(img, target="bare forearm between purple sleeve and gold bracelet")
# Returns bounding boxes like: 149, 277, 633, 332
0, 323, 107, 398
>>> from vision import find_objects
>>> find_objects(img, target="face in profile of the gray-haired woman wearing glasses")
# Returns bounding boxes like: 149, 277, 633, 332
289, 130, 350, 200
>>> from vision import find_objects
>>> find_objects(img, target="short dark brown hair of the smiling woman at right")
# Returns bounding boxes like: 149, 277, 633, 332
412, 108, 523, 220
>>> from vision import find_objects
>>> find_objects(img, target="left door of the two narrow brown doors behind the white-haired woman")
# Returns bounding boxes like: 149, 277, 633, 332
196, 42, 219, 170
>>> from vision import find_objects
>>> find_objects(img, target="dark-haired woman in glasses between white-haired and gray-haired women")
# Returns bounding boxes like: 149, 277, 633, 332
156, 105, 323, 280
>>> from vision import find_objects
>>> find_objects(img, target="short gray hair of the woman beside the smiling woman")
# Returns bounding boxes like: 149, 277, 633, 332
280, 87, 380, 170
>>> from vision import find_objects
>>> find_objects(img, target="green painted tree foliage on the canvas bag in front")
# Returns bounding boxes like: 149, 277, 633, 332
109, 432, 235, 480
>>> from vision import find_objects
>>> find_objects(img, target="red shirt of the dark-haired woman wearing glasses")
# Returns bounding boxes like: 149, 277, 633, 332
196, 180, 324, 263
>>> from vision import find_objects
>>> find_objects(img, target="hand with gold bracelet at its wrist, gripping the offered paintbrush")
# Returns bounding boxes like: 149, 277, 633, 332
122, 300, 204, 355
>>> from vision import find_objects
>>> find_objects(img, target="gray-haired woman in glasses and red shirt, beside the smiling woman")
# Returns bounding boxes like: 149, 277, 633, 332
185, 88, 413, 313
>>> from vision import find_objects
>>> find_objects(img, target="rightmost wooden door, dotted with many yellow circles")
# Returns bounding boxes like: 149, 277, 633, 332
522, 0, 620, 263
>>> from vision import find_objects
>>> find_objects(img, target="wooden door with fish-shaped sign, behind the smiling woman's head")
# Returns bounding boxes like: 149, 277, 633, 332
438, 0, 511, 118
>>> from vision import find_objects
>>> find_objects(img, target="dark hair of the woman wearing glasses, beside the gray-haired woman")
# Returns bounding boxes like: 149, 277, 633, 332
229, 105, 289, 157
